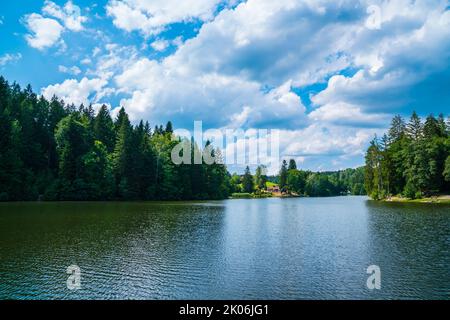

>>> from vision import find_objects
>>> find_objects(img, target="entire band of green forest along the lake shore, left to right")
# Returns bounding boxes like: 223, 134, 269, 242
0, 77, 400, 201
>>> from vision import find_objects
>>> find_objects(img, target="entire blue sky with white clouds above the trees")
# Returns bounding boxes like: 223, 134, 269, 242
0, 0, 450, 171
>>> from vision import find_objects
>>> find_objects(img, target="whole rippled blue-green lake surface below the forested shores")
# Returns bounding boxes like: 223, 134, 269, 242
0, 197, 450, 299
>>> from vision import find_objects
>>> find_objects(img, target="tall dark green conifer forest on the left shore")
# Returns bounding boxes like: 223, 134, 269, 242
0, 77, 230, 201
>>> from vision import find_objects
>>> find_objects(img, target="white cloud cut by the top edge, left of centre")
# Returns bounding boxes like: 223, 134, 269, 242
106, 0, 225, 35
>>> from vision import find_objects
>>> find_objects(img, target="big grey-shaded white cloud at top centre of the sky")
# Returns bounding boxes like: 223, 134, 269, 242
162, 0, 360, 86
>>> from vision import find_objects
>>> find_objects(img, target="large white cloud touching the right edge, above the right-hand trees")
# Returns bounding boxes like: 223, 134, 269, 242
312, 6, 450, 112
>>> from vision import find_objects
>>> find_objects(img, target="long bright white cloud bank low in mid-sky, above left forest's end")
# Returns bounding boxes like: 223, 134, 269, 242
115, 58, 305, 127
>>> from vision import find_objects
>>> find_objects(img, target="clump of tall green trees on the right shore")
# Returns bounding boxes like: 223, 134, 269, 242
365, 112, 450, 199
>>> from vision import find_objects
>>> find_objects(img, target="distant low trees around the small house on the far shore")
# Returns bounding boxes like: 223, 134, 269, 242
231, 159, 366, 197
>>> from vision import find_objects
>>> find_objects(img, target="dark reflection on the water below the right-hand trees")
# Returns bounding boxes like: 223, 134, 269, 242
367, 201, 450, 299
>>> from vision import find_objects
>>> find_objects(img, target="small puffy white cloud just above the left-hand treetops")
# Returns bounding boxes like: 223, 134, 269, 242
42, 77, 107, 106
